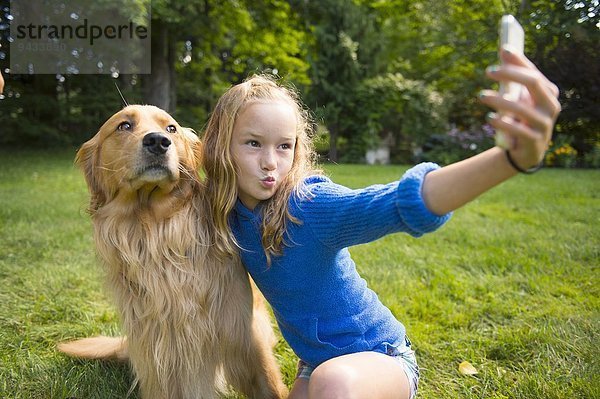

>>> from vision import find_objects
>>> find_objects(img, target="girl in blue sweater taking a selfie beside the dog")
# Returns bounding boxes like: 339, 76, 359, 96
204, 49, 560, 398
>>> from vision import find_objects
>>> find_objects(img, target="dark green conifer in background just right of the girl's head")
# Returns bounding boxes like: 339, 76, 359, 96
292, 0, 378, 162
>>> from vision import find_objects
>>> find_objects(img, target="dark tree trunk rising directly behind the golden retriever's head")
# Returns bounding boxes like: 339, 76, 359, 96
144, 20, 175, 112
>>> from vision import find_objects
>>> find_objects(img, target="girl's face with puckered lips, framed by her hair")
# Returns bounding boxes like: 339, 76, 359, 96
230, 102, 297, 209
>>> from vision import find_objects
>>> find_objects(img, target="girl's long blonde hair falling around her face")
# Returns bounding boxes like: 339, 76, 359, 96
203, 75, 319, 263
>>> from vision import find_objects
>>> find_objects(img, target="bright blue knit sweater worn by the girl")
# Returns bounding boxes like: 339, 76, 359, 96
230, 163, 450, 367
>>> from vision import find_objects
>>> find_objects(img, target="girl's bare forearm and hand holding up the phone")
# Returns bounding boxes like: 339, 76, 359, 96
422, 48, 560, 215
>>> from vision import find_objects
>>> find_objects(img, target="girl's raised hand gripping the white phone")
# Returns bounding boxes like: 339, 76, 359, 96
480, 47, 561, 169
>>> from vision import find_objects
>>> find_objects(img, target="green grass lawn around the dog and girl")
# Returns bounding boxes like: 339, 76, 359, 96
0, 151, 600, 399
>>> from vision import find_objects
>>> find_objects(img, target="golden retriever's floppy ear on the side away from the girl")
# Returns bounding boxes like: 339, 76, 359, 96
75, 135, 107, 215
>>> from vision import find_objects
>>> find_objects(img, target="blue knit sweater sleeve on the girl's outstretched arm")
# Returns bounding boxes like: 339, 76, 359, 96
294, 163, 451, 249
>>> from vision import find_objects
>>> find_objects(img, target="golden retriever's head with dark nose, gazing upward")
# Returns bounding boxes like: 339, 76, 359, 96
75, 105, 201, 214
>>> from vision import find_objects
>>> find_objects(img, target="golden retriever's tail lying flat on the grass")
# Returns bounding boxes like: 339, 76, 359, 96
58, 336, 129, 361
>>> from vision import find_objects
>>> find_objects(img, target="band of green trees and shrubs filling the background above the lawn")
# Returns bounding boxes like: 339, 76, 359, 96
0, 0, 600, 167
